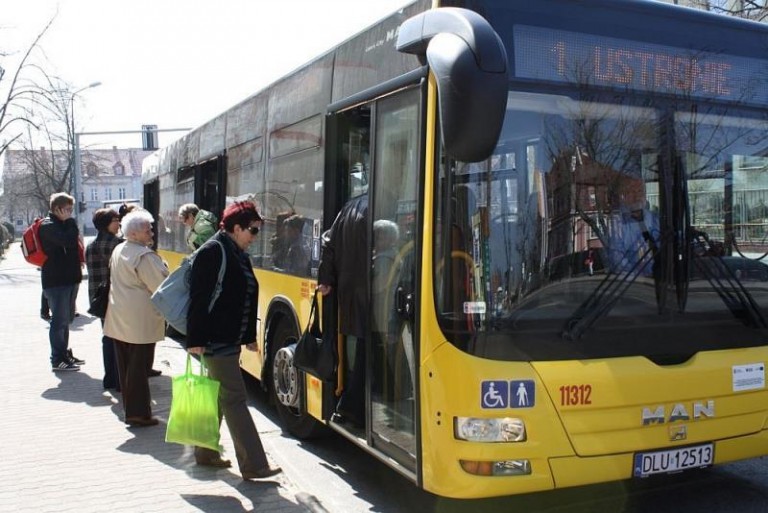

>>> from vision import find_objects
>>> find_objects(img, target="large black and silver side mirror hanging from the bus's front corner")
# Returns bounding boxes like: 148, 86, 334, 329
397, 7, 509, 162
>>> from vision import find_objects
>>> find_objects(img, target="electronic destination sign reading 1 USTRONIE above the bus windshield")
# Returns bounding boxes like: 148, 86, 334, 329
513, 25, 768, 104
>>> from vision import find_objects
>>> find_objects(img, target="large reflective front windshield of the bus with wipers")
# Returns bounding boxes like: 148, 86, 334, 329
434, 91, 768, 363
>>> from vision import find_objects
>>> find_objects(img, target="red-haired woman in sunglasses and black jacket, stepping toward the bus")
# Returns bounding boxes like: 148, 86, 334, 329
186, 201, 281, 480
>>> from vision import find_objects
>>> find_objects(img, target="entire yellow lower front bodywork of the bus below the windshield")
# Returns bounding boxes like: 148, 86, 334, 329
421, 333, 768, 498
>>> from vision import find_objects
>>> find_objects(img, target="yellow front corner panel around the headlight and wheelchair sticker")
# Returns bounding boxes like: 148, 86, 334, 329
420, 343, 573, 498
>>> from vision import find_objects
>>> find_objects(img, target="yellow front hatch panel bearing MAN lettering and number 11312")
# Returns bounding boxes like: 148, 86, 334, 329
534, 347, 768, 456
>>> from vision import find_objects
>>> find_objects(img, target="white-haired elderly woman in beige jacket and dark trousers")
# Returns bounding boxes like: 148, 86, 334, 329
104, 210, 168, 427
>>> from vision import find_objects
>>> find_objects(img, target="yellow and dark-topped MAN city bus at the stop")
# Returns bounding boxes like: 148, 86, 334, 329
143, 0, 768, 498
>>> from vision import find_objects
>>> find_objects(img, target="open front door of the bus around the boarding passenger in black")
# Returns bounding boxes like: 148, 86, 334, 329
326, 87, 422, 473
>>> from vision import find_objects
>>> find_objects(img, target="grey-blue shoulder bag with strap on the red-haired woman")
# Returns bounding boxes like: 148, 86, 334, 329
151, 239, 227, 335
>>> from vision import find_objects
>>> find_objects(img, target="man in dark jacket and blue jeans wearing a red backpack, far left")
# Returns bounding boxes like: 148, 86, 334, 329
39, 192, 85, 371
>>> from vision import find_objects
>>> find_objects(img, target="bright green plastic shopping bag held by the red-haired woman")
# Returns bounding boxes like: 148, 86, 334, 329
165, 354, 221, 451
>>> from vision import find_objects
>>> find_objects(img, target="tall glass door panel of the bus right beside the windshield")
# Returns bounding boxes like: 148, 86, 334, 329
369, 90, 421, 468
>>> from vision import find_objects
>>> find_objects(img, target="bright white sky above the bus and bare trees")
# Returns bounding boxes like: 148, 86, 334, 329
0, 0, 411, 147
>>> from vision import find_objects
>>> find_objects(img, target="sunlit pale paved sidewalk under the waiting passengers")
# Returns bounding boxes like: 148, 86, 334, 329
0, 242, 307, 513
